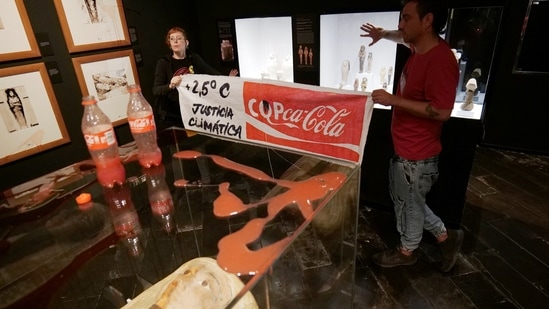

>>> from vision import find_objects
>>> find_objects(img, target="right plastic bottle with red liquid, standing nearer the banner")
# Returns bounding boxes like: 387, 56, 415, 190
128, 84, 162, 167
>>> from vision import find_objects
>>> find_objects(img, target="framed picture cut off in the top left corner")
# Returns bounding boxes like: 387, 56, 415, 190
0, 0, 40, 62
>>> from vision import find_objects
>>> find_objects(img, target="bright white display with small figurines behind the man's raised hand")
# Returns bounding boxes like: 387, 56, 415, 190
320, 11, 400, 108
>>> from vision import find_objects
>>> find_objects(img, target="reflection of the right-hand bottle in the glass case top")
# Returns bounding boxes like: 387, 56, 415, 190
143, 164, 174, 233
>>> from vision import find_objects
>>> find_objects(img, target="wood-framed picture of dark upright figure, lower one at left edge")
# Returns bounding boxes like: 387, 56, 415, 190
0, 63, 70, 165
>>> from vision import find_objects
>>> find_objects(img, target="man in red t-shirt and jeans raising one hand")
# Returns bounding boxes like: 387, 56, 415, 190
361, 0, 463, 272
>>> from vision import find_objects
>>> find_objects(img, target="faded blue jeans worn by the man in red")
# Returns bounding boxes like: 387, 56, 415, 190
389, 156, 446, 250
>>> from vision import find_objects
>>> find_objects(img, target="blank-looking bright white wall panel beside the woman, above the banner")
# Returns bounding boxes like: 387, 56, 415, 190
235, 17, 294, 82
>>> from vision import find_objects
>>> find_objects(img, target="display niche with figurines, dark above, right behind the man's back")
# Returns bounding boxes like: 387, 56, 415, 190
445, 7, 503, 120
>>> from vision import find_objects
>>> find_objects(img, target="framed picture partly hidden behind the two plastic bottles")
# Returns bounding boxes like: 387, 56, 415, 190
72, 49, 139, 126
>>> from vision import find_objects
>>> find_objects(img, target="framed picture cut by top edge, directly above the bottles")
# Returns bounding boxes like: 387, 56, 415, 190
54, 0, 131, 53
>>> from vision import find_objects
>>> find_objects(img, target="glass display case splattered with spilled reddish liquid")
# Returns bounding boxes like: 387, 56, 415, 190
0, 129, 360, 308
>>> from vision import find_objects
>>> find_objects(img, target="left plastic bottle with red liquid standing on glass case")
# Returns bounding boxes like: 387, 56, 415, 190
82, 96, 126, 187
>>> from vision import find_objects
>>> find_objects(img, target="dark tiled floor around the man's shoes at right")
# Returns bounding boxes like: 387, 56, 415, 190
354, 147, 549, 308
